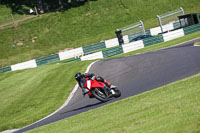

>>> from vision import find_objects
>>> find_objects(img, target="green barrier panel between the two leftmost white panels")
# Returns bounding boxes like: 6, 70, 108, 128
36, 54, 60, 66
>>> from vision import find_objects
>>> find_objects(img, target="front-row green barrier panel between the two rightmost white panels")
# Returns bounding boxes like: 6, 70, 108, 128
143, 35, 164, 47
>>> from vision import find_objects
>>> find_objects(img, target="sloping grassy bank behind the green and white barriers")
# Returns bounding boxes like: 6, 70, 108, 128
0, 0, 200, 67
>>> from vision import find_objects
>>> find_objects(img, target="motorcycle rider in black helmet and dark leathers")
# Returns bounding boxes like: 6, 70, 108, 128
75, 72, 111, 95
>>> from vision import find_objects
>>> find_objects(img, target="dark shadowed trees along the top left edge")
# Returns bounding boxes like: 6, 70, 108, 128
0, 0, 96, 14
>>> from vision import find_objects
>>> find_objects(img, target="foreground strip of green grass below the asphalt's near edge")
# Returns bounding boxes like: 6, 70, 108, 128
29, 74, 200, 133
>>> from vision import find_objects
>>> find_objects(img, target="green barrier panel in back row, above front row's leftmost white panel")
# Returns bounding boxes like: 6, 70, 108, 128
83, 42, 106, 54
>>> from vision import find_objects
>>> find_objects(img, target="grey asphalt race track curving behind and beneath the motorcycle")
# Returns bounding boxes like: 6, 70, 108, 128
17, 39, 200, 132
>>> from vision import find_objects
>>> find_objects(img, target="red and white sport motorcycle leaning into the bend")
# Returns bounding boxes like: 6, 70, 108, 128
84, 78, 121, 102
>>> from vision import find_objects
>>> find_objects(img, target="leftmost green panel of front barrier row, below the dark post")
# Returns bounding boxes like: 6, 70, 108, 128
102, 46, 123, 57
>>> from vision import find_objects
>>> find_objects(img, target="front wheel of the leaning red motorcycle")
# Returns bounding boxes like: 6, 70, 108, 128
91, 88, 109, 102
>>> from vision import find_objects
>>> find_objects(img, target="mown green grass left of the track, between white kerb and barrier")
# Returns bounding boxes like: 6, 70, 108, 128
0, 61, 91, 131
